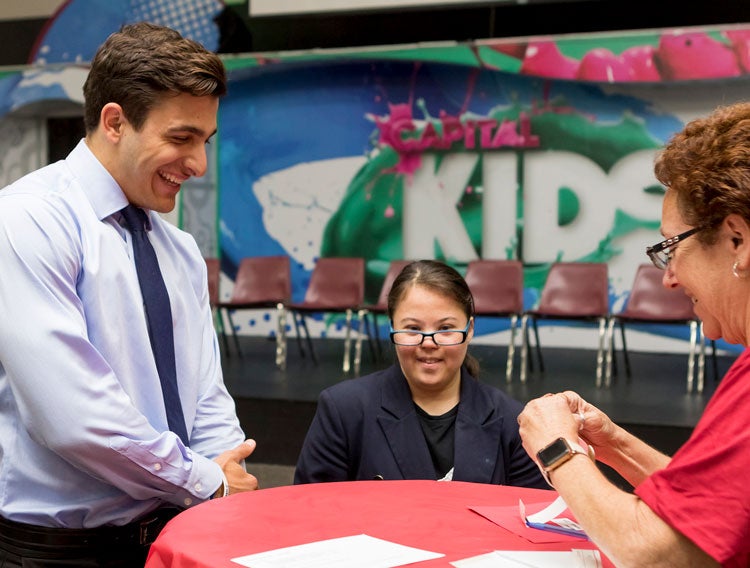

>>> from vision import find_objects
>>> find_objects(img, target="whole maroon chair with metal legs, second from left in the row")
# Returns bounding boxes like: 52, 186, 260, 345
217, 255, 292, 369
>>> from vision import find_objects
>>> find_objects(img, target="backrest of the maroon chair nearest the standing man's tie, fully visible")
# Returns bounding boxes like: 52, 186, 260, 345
230, 255, 292, 305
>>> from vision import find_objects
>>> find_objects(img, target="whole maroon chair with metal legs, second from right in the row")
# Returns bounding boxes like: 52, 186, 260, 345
521, 262, 609, 387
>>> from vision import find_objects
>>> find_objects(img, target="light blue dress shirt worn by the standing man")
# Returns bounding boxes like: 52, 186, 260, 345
0, 140, 245, 528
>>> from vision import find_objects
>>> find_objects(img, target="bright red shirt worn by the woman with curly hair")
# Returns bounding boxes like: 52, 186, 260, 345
635, 349, 750, 568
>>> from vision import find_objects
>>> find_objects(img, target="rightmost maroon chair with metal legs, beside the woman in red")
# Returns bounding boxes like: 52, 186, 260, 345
606, 263, 717, 392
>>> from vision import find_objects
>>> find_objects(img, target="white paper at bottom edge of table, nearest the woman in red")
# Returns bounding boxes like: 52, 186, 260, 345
450, 549, 602, 568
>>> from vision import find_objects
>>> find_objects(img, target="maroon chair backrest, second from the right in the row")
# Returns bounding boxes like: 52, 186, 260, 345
534, 262, 609, 318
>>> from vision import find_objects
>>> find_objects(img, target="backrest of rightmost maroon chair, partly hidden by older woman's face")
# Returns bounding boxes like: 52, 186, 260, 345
619, 263, 696, 322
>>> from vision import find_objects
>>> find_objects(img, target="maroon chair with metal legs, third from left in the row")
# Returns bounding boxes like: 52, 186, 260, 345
287, 257, 365, 373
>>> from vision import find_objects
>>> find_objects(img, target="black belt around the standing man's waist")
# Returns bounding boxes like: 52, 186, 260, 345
0, 507, 182, 548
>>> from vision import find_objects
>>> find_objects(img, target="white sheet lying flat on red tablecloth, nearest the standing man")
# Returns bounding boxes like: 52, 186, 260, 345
232, 534, 445, 568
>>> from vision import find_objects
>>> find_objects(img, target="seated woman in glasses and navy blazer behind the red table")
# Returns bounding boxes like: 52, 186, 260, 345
294, 260, 548, 488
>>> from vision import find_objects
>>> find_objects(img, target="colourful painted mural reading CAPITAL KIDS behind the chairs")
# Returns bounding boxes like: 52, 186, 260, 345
218, 52, 748, 349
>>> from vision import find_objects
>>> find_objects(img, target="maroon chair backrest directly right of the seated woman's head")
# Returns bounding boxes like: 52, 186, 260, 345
465, 259, 523, 316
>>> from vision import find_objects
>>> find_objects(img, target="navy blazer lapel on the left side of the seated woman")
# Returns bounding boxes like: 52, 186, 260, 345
378, 365, 435, 479
